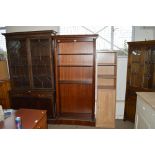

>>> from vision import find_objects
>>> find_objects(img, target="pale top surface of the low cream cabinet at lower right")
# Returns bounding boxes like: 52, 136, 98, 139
137, 92, 155, 109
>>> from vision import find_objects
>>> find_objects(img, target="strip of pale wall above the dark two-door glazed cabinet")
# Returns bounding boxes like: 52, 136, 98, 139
6, 26, 59, 33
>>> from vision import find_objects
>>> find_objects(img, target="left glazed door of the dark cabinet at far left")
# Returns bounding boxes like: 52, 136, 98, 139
7, 39, 30, 88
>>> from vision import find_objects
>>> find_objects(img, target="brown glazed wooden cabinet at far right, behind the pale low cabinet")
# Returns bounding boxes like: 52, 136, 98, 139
124, 41, 155, 122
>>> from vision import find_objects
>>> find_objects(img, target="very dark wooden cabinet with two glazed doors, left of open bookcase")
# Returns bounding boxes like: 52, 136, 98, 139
4, 31, 55, 118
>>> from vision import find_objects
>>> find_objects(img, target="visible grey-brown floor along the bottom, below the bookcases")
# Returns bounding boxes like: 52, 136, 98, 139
48, 120, 134, 129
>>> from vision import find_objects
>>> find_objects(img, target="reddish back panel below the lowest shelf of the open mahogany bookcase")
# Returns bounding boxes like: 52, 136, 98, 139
60, 84, 93, 113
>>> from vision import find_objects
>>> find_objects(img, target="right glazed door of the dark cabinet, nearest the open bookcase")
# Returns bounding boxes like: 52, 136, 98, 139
30, 38, 53, 89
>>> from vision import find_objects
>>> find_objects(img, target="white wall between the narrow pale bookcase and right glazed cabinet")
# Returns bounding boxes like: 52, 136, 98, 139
116, 56, 128, 119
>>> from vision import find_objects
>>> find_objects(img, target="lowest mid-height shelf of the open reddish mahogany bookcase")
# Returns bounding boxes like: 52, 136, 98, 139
59, 80, 92, 84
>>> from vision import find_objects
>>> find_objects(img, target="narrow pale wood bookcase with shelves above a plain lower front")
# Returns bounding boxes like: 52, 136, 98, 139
96, 52, 117, 128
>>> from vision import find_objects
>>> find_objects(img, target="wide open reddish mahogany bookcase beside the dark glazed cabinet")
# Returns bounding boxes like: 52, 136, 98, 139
55, 35, 97, 122
